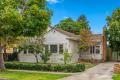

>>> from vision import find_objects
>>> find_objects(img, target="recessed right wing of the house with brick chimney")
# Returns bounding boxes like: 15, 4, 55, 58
80, 34, 106, 62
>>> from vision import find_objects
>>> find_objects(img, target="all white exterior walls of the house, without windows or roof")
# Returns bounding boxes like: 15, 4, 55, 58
19, 29, 103, 63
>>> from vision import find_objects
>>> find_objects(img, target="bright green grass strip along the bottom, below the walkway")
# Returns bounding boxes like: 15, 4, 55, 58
0, 71, 70, 80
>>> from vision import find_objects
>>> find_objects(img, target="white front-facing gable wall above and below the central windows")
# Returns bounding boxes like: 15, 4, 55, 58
44, 30, 68, 63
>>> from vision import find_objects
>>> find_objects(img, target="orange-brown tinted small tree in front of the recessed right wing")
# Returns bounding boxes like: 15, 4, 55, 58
79, 28, 97, 61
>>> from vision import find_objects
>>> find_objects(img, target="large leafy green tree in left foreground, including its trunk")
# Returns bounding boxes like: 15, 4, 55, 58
0, 0, 51, 70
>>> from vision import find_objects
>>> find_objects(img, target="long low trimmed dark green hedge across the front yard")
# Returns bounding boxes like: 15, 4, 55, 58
5, 62, 85, 72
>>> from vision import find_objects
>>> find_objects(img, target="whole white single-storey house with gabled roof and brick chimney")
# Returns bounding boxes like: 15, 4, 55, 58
19, 27, 105, 63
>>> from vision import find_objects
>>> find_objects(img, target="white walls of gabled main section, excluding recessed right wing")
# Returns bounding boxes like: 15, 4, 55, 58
19, 30, 79, 63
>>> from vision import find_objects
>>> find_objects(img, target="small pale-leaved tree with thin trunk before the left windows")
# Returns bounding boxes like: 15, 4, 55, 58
19, 36, 44, 63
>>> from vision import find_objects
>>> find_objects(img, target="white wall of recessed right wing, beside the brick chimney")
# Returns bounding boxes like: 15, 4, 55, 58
80, 43, 103, 60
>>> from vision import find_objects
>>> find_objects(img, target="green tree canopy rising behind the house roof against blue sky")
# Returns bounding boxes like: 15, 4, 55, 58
55, 15, 90, 35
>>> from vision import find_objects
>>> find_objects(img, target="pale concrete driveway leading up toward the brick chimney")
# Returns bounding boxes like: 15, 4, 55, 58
59, 62, 115, 80
